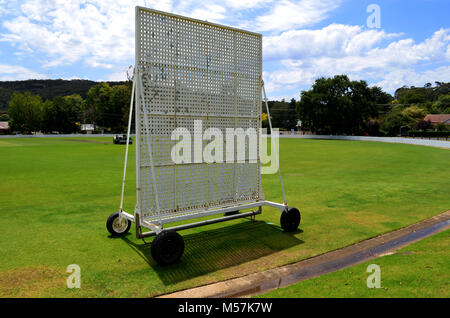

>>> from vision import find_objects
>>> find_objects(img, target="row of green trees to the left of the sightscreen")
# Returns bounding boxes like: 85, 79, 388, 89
6, 82, 131, 134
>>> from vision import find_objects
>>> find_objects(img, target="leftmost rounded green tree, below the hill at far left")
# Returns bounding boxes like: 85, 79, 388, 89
8, 92, 43, 134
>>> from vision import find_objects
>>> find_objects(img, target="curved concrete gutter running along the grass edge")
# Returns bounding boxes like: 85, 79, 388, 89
160, 210, 450, 298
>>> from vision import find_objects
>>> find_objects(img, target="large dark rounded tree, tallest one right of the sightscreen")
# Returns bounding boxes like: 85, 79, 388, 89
297, 75, 378, 134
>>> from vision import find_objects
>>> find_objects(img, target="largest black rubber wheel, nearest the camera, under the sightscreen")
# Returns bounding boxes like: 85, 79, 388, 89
152, 231, 184, 266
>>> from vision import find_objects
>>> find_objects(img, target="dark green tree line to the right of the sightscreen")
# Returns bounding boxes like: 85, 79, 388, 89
262, 75, 450, 136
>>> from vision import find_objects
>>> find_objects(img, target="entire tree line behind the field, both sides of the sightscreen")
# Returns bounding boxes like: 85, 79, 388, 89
0, 75, 450, 136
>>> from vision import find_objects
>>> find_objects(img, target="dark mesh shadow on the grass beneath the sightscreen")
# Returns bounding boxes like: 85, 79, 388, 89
122, 221, 304, 285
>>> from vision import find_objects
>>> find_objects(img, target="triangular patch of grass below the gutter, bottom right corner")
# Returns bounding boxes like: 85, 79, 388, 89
257, 230, 450, 298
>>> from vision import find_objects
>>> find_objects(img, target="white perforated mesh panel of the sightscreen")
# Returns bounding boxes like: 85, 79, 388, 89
136, 7, 262, 219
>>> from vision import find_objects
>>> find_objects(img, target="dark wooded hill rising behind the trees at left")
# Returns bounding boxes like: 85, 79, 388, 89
0, 79, 125, 110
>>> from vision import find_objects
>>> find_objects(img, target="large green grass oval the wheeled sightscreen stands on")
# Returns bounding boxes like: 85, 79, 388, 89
0, 137, 450, 297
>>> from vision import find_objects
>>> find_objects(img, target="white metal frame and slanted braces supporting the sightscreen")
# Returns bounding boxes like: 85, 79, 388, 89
119, 7, 288, 238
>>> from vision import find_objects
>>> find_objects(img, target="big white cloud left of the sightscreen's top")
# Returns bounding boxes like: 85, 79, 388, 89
0, 0, 151, 68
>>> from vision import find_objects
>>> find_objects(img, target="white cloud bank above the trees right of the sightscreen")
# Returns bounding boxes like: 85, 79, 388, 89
267, 25, 450, 92
